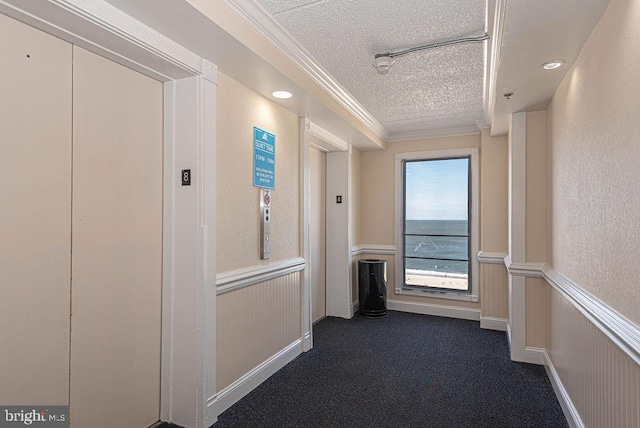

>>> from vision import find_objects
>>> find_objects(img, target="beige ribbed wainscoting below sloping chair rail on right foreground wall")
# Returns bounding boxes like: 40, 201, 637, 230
546, 289, 640, 427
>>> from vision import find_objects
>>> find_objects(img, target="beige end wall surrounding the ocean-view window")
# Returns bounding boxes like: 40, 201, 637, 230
360, 134, 508, 318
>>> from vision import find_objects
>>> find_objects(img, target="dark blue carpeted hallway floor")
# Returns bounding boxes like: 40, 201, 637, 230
213, 312, 568, 428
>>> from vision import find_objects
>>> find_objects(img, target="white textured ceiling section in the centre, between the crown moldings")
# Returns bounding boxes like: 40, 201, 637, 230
255, 0, 486, 137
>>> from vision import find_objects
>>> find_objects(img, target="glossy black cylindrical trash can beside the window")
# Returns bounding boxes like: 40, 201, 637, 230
358, 259, 387, 318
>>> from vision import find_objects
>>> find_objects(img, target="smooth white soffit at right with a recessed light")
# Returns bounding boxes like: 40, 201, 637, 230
490, 0, 614, 135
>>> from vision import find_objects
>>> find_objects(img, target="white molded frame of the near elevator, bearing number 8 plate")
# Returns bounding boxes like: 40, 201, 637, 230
0, 0, 217, 428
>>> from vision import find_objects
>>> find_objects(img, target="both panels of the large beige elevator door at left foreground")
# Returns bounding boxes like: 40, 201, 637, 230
0, 14, 163, 428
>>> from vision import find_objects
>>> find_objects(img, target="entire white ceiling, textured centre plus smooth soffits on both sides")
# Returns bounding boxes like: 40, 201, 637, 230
94, 0, 609, 150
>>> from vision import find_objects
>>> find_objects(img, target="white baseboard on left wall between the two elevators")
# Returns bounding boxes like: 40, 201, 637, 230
207, 339, 303, 417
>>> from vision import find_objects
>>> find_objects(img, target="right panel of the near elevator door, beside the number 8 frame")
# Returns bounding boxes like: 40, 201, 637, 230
71, 47, 163, 428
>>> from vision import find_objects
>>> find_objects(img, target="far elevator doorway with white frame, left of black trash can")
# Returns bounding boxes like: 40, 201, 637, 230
301, 119, 353, 332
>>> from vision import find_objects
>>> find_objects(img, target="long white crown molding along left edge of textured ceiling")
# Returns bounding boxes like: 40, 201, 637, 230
222, 0, 389, 141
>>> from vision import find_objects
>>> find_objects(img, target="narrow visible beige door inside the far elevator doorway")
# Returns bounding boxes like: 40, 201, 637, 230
309, 148, 327, 322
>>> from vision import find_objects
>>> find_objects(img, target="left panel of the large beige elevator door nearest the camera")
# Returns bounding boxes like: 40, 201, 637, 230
0, 14, 72, 405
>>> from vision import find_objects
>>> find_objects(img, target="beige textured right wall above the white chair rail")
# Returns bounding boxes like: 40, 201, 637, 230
547, 0, 640, 324
